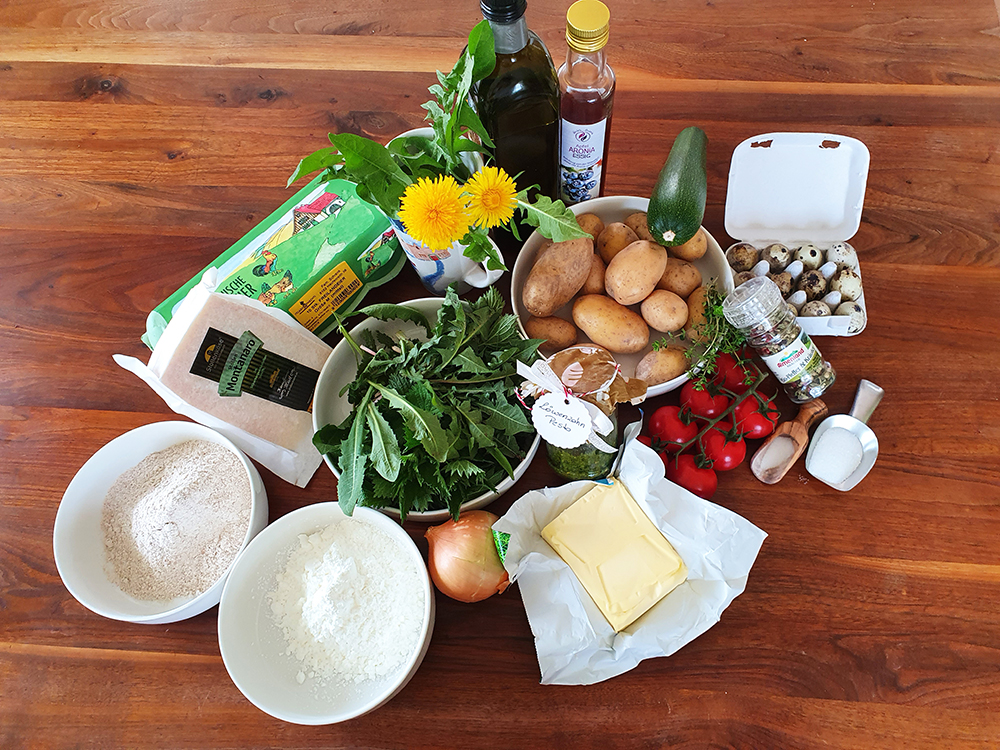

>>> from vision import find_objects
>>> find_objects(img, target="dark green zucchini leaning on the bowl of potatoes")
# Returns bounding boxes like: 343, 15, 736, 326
646, 126, 708, 247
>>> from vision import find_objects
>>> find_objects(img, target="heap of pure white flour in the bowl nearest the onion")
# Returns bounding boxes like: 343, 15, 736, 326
267, 518, 424, 683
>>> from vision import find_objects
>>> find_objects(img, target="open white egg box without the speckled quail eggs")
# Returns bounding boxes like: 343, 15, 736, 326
726, 133, 870, 336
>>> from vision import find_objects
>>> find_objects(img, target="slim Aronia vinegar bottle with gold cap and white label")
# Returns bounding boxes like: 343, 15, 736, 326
559, 0, 615, 205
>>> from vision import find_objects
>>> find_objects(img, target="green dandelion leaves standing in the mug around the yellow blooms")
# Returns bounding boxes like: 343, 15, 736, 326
288, 21, 588, 269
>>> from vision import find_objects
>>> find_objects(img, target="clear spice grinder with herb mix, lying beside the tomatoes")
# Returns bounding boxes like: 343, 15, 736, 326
722, 276, 837, 404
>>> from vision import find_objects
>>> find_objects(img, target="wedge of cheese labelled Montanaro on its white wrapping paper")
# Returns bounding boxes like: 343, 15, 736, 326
115, 271, 332, 487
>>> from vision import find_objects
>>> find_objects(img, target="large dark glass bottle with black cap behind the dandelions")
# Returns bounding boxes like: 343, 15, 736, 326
472, 0, 559, 217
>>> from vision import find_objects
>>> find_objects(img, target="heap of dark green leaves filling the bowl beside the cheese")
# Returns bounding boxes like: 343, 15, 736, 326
313, 288, 540, 519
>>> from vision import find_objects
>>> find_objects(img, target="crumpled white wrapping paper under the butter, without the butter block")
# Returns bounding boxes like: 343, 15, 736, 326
493, 440, 767, 685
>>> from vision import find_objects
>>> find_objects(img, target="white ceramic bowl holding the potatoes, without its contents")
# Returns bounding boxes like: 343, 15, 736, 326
510, 195, 733, 396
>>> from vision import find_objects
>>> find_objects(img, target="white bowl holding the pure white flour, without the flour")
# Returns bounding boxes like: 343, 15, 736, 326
219, 503, 434, 724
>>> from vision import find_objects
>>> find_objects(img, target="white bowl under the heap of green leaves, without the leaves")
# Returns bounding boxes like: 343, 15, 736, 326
313, 297, 541, 523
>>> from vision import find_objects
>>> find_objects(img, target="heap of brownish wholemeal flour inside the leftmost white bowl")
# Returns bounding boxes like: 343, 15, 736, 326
101, 440, 251, 602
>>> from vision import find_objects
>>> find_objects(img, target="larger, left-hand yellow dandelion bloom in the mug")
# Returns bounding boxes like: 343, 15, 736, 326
399, 175, 471, 250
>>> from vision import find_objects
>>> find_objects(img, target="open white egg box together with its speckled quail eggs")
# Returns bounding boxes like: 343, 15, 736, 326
726, 133, 870, 336
